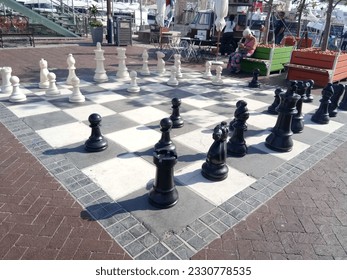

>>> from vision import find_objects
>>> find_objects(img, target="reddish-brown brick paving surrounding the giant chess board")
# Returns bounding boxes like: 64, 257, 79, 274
0, 37, 347, 260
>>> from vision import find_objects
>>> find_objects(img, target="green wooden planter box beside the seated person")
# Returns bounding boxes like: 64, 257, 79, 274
241, 46, 293, 76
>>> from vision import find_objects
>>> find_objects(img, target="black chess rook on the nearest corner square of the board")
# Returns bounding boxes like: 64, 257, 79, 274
148, 150, 178, 209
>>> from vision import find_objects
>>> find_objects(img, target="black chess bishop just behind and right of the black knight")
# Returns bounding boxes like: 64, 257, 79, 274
227, 100, 249, 157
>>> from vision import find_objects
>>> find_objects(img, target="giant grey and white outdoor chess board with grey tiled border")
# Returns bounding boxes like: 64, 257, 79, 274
0, 70, 347, 259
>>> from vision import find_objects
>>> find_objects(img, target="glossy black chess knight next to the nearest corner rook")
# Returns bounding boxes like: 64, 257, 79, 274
201, 122, 229, 181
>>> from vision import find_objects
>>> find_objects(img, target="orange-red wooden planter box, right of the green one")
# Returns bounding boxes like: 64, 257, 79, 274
287, 49, 347, 87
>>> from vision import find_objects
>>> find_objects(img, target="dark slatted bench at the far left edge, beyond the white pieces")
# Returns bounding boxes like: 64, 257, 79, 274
0, 15, 35, 48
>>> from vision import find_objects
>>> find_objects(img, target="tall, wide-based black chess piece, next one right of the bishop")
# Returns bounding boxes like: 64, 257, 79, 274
265, 81, 300, 152
